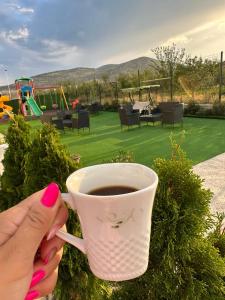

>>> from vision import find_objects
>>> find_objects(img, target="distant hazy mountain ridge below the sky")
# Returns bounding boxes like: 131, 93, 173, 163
0, 57, 157, 90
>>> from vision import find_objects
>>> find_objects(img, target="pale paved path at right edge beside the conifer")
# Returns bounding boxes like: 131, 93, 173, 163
193, 153, 225, 213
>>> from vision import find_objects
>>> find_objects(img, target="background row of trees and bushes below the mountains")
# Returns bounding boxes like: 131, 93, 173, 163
35, 44, 225, 104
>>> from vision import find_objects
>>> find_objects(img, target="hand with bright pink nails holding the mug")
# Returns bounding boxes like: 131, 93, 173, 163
0, 183, 67, 300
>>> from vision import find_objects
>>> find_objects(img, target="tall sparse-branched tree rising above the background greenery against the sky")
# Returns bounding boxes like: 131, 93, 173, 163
152, 44, 185, 101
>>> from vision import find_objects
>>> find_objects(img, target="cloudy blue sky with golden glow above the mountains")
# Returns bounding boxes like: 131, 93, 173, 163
0, 0, 225, 85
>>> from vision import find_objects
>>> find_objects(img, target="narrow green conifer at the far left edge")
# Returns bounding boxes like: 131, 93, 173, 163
0, 115, 31, 210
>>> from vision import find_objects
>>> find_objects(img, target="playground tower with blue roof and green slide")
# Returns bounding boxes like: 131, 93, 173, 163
15, 77, 43, 116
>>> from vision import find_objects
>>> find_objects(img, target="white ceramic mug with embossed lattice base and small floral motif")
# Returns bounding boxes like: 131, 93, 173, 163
57, 163, 158, 281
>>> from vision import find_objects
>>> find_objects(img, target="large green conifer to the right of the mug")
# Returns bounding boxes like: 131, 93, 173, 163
112, 144, 225, 300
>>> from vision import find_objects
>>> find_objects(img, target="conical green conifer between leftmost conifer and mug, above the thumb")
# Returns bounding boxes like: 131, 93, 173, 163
24, 124, 77, 196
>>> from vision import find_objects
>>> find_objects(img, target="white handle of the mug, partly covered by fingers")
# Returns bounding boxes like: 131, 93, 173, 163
56, 193, 86, 254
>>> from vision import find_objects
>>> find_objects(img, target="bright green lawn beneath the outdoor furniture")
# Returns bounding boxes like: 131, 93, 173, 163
0, 112, 225, 166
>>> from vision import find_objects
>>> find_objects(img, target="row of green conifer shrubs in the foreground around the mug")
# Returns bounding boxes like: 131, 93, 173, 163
0, 116, 225, 300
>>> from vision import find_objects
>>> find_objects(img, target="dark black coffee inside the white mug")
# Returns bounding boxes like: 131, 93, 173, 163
87, 185, 137, 196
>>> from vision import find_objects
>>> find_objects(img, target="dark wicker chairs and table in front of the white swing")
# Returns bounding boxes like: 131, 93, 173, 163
119, 102, 183, 129
